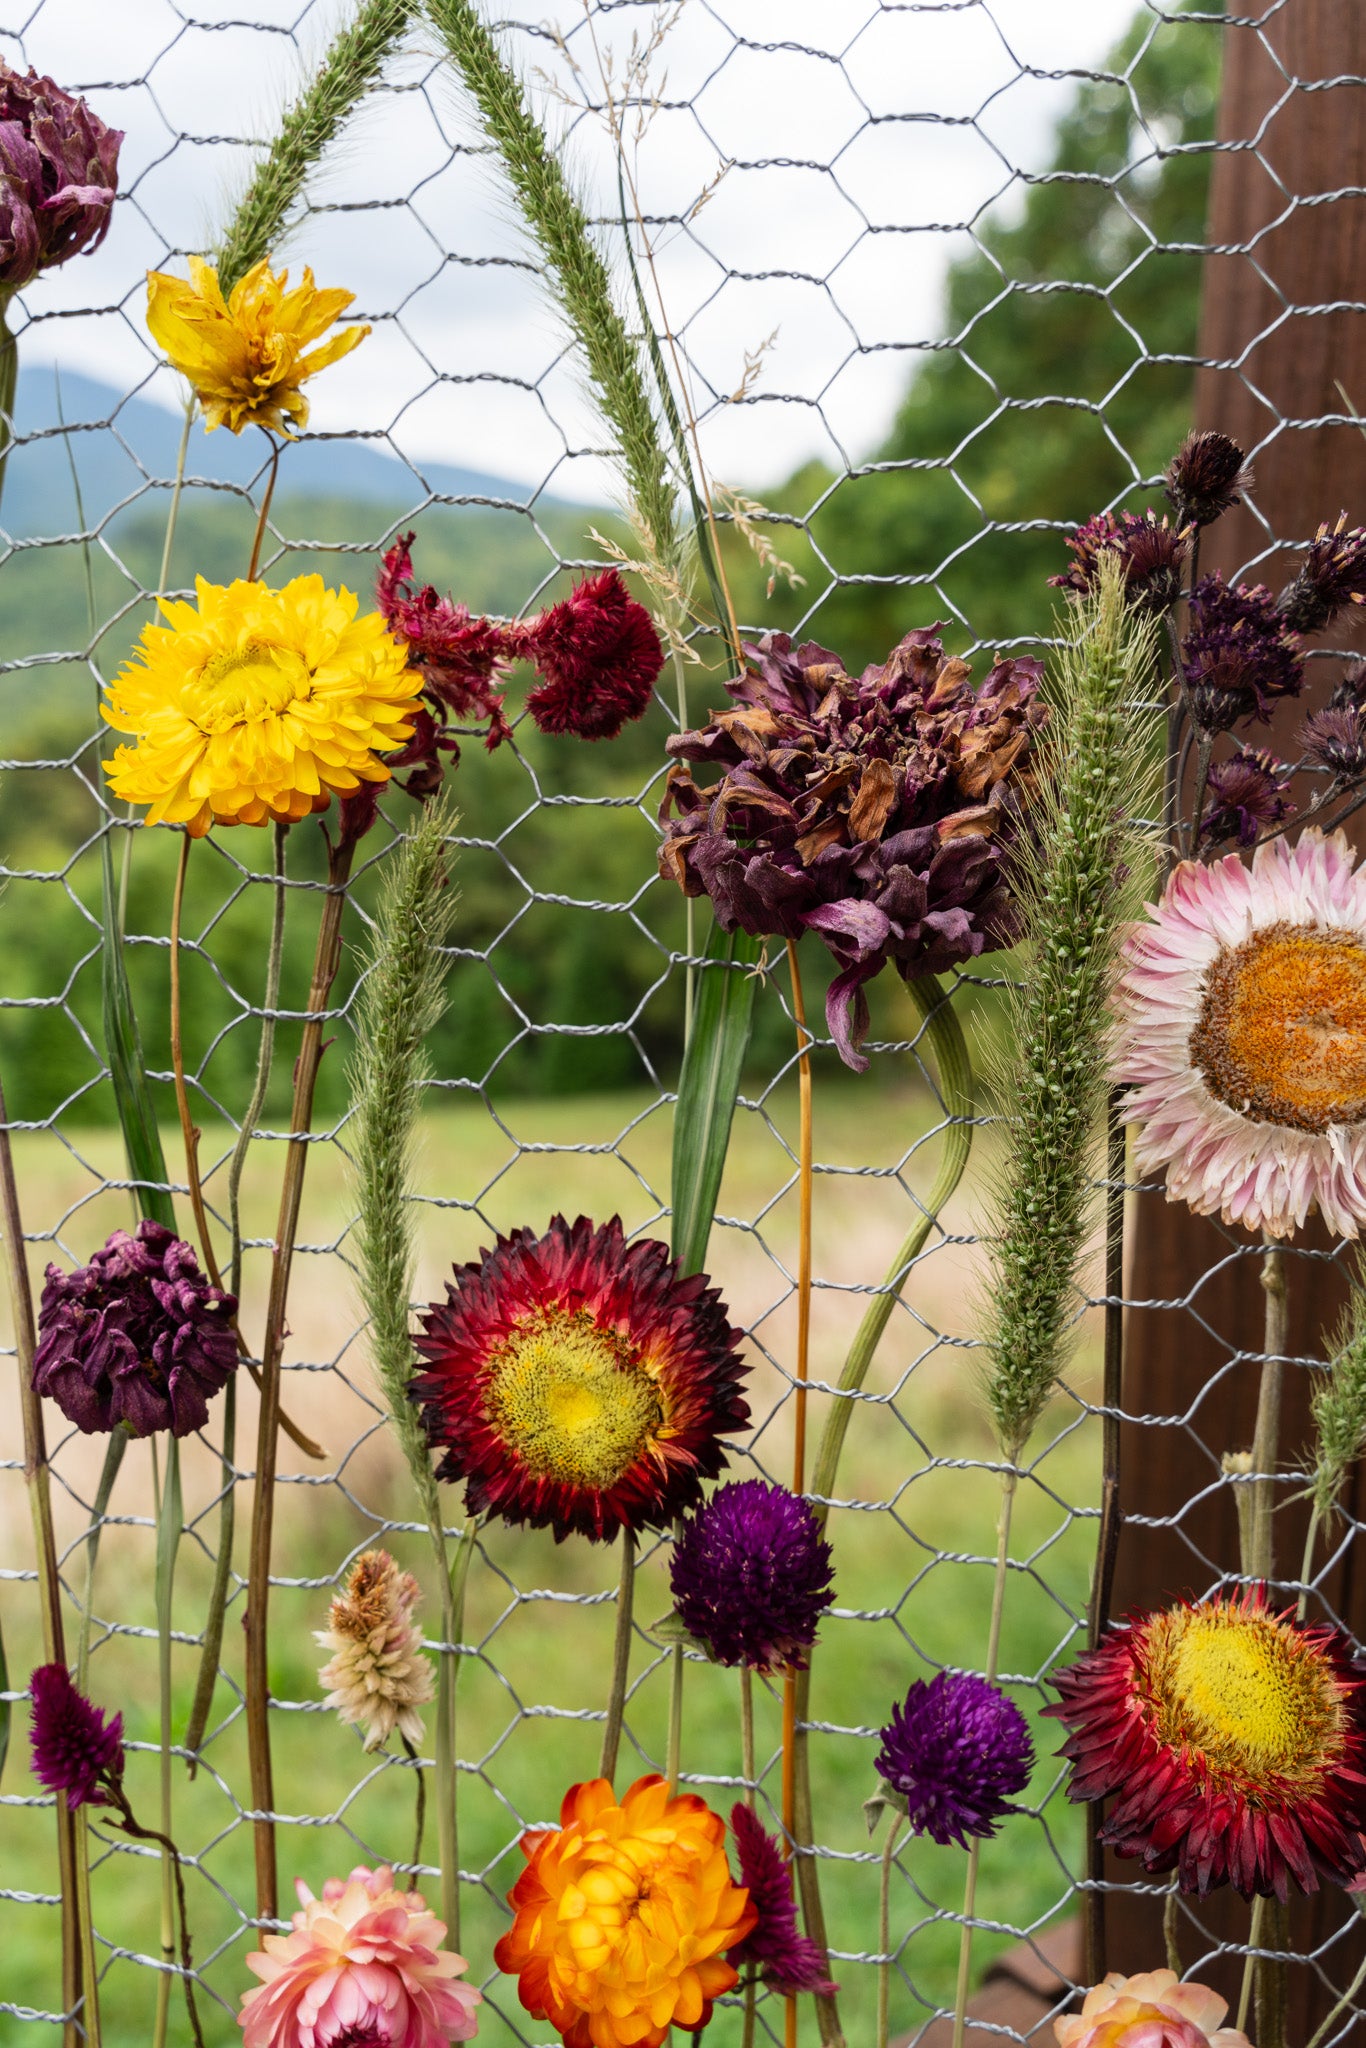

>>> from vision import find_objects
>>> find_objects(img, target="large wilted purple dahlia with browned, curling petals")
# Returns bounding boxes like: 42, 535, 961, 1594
659, 627, 1047, 1071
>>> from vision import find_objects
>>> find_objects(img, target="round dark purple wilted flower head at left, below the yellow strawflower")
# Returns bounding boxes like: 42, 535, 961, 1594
33, 1217, 238, 1436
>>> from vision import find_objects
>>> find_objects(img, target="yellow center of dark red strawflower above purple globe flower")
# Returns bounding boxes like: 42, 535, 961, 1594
485, 1309, 664, 1489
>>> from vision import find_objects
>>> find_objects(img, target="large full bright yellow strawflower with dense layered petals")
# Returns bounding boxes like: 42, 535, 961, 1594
100, 575, 422, 838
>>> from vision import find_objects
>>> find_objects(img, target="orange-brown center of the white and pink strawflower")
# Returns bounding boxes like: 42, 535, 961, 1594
1190, 924, 1366, 1130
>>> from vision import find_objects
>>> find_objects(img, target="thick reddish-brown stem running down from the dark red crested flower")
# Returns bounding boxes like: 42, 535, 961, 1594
244, 840, 354, 1921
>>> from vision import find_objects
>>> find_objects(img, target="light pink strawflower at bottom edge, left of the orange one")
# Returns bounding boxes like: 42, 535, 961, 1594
238, 1864, 483, 2048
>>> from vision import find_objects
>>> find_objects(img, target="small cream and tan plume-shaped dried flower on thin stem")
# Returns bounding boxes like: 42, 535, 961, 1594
315, 1550, 432, 1749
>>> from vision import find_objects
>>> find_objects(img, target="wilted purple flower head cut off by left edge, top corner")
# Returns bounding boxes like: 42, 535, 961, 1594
0, 63, 123, 293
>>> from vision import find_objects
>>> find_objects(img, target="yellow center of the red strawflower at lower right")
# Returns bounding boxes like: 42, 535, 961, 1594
1145, 1606, 1343, 1790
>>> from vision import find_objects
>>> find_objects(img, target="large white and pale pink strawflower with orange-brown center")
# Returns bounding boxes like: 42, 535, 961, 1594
1114, 827, 1366, 1237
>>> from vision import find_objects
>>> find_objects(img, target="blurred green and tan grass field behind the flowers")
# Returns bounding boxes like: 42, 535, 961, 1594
0, 1073, 1096, 2048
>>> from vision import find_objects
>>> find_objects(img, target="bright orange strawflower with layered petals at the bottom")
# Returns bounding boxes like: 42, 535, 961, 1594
494, 1778, 758, 2048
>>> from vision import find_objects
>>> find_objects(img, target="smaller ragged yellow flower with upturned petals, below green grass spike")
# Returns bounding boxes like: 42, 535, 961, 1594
147, 256, 371, 434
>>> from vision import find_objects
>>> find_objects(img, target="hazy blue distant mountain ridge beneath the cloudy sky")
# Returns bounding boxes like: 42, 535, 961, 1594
0, 367, 563, 539
